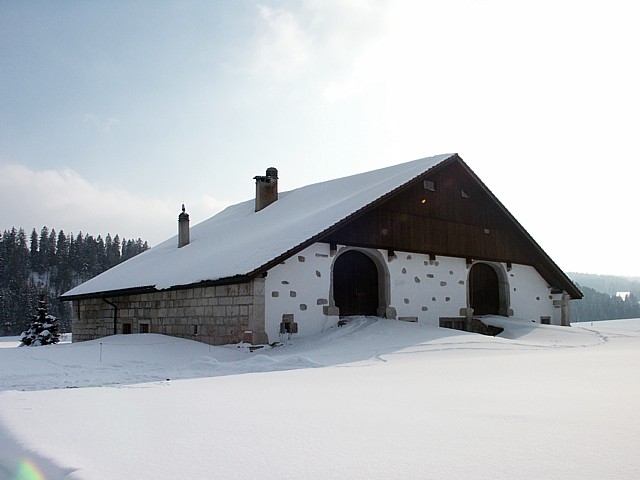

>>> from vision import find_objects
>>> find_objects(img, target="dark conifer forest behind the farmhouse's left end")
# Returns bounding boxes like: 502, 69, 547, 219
0, 226, 149, 335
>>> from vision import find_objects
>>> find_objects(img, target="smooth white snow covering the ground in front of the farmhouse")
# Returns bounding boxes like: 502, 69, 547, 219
0, 318, 640, 480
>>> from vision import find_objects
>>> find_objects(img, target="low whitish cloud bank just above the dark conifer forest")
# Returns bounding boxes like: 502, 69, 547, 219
0, 163, 226, 245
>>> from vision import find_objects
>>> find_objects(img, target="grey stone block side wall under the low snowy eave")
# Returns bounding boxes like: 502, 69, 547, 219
73, 278, 267, 345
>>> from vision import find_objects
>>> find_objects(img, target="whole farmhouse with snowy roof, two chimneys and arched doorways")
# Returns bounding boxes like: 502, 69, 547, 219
62, 154, 582, 344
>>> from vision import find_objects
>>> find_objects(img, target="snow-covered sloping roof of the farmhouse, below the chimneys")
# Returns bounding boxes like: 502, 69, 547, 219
63, 154, 457, 298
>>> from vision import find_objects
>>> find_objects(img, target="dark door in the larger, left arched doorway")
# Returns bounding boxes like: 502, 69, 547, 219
333, 250, 380, 317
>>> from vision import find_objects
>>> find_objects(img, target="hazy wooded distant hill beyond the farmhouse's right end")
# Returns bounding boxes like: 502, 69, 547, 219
567, 272, 640, 322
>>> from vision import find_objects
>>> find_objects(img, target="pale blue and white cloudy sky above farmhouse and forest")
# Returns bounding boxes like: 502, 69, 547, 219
0, 0, 640, 276
